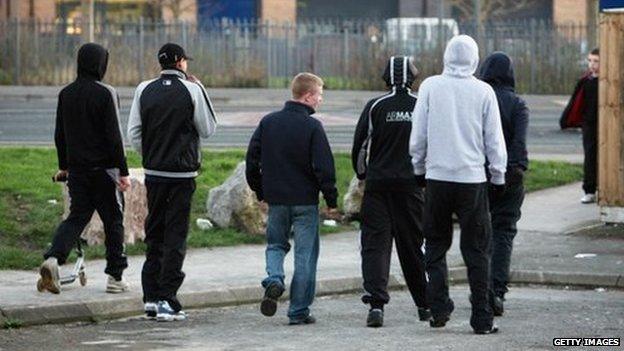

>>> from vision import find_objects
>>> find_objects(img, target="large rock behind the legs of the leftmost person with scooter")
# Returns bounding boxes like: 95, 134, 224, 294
63, 168, 147, 245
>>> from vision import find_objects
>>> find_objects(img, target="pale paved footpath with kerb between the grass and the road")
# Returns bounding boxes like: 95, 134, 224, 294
0, 183, 624, 324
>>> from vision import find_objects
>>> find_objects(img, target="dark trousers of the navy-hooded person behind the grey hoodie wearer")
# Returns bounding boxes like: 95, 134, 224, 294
490, 182, 524, 297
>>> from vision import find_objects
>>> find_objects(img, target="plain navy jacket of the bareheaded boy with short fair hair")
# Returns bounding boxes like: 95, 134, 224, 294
245, 101, 338, 208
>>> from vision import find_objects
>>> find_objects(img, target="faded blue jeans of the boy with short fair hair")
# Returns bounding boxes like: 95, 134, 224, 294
262, 205, 319, 320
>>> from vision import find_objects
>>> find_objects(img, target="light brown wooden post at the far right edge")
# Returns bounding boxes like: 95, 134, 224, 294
598, 12, 624, 223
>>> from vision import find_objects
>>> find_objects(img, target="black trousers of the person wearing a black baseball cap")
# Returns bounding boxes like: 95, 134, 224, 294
141, 178, 195, 311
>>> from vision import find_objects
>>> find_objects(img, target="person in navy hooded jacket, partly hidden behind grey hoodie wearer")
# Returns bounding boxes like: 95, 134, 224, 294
479, 52, 529, 316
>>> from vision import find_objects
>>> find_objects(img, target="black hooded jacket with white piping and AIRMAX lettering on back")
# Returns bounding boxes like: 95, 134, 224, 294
351, 58, 416, 191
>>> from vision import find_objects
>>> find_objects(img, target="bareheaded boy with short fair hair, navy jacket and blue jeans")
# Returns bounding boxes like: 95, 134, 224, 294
245, 73, 338, 325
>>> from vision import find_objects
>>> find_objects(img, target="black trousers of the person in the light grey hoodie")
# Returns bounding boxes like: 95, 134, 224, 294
424, 180, 493, 329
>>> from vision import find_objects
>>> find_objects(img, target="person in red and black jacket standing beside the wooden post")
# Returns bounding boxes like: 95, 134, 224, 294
559, 49, 600, 204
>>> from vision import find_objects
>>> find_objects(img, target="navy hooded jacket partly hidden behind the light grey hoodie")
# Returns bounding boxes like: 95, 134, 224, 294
479, 52, 529, 171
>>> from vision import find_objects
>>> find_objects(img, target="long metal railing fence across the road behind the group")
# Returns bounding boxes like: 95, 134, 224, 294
0, 19, 592, 94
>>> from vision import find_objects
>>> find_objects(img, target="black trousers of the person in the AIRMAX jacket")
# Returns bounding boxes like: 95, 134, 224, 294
360, 189, 428, 308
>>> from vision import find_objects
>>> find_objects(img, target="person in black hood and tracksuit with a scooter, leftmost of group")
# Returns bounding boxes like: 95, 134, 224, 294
40, 43, 130, 294
